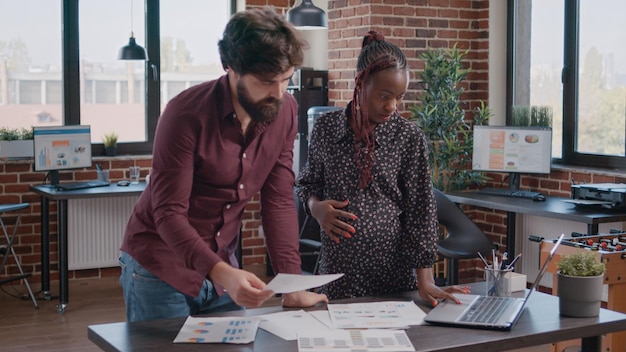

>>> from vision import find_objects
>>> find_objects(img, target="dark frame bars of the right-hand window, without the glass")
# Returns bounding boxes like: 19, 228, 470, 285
506, 0, 626, 169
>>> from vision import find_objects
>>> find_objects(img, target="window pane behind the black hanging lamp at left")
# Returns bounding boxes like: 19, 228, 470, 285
78, 0, 148, 145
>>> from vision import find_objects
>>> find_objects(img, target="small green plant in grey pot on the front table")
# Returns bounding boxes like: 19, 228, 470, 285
556, 250, 606, 317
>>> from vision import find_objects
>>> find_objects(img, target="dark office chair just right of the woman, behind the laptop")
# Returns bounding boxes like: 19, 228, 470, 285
434, 189, 494, 285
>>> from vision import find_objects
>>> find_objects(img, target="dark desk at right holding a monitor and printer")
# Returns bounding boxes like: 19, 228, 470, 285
446, 192, 626, 253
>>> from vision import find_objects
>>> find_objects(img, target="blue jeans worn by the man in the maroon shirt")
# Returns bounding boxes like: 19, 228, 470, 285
119, 252, 242, 322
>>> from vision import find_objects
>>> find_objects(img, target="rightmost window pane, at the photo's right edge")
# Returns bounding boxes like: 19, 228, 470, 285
566, 0, 626, 160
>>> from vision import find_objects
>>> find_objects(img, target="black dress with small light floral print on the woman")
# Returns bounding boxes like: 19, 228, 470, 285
297, 110, 438, 299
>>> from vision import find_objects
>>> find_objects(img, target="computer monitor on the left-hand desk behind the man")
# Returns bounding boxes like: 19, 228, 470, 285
33, 125, 91, 186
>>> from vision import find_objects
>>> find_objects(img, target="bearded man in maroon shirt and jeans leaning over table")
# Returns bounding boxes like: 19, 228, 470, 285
120, 8, 328, 321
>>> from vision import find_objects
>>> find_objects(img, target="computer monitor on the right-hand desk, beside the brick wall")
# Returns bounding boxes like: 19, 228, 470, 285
472, 126, 552, 190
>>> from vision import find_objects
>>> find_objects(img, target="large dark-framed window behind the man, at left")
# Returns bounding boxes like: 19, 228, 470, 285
0, 0, 234, 155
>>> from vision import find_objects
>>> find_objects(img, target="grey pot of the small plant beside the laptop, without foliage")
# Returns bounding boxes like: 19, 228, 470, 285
557, 272, 604, 318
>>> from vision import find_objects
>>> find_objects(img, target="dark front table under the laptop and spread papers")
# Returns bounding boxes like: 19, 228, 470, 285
88, 288, 626, 352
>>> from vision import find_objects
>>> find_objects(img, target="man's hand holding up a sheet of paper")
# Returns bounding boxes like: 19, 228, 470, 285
209, 262, 274, 308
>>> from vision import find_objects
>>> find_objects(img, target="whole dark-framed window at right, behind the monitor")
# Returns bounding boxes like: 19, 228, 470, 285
507, 0, 626, 168
